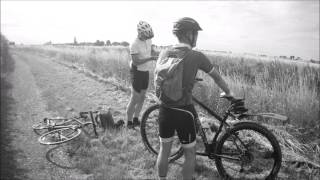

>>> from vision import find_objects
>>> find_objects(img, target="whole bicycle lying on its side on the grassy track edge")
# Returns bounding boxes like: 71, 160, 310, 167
32, 111, 100, 145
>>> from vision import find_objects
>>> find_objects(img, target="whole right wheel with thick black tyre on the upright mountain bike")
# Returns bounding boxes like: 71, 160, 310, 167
215, 121, 282, 180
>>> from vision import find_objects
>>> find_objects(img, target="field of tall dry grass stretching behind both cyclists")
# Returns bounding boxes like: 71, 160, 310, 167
21, 46, 320, 135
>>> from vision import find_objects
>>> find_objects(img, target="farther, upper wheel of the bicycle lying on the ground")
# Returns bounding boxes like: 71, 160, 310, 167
32, 118, 73, 135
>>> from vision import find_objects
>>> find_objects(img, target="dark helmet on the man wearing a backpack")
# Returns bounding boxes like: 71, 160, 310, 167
172, 17, 202, 33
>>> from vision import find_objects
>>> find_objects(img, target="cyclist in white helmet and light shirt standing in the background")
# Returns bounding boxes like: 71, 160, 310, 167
127, 21, 157, 128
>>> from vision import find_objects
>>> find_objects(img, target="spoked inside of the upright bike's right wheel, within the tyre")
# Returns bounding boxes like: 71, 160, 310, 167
218, 124, 277, 179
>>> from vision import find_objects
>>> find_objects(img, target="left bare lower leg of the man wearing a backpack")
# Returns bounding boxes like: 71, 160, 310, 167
156, 141, 172, 179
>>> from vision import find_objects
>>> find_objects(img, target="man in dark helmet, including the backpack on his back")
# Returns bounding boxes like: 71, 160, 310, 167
154, 17, 231, 180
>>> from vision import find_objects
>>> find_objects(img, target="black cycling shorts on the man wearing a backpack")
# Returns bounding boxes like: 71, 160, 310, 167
159, 105, 198, 147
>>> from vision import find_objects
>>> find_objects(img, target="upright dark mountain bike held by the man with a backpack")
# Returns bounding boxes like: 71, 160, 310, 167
140, 80, 286, 180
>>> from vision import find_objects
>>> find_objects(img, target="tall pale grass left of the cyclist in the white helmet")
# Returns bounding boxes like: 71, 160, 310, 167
18, 45, 130, 85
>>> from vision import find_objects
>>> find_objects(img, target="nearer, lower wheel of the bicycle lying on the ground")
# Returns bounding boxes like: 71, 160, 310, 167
38, 128, 81, 145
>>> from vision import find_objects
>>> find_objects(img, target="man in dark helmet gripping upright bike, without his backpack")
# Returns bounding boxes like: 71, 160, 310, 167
156, 17, 231, 180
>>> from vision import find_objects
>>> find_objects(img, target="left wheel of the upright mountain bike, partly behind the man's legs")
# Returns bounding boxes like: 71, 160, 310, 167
140, 104, 183, 162
